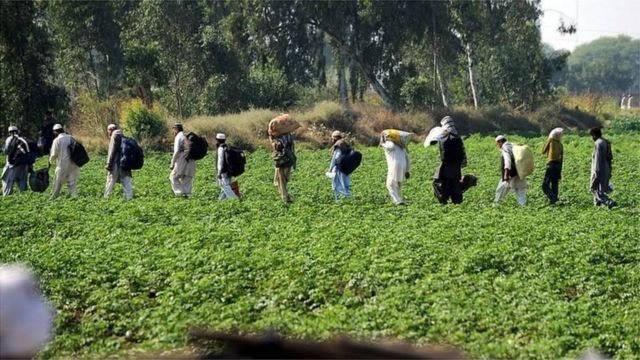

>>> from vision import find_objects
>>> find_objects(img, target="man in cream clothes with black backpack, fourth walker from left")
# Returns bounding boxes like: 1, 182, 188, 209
169, 123, 196, 197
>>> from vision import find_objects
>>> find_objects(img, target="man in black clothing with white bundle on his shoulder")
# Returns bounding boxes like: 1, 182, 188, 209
433, 116, 467, 204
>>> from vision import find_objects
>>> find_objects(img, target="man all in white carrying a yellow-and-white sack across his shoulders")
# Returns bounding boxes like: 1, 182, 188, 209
381, 139, 411, 205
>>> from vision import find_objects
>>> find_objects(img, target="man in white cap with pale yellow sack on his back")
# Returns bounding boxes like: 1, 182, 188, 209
493, 135, 528, 206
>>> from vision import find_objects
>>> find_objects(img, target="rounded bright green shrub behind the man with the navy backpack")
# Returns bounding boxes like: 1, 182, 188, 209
120, 99, 167, 139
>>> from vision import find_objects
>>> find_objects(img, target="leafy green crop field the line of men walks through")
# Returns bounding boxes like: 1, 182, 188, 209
0, 133, 640, 359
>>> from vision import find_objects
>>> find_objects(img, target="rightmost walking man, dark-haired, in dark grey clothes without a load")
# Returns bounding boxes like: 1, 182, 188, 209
589, 128, 617, 209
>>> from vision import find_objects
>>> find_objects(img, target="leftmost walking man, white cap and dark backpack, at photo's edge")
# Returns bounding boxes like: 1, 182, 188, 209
2, 125, 31, 196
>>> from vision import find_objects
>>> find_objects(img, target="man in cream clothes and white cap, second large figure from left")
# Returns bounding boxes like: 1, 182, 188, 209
49, 124, 80, 199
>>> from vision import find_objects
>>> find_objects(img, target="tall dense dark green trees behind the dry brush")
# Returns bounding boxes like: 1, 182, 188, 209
0, 0, 636, 138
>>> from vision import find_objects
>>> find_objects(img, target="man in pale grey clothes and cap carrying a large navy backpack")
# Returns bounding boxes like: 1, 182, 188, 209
104, 124, 133, 200
